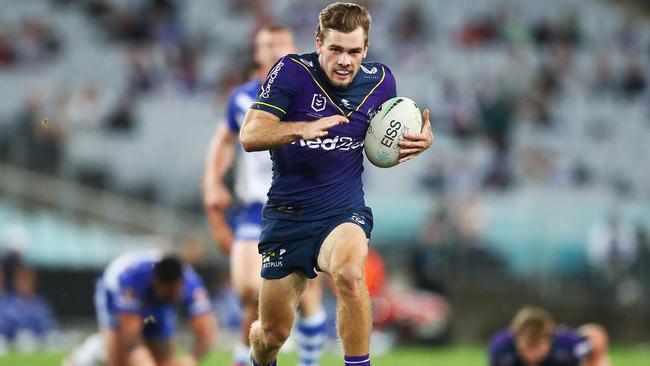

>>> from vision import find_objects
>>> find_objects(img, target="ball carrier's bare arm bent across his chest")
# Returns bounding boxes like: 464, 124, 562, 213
239, 109, 349, 151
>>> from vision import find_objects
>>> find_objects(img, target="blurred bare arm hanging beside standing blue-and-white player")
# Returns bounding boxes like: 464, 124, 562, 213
202, 123, 237, 253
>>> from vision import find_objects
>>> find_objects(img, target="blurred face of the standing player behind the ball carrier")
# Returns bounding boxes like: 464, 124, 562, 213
255, 30, 297, 74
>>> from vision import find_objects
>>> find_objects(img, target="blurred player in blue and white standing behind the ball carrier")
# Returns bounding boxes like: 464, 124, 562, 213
203, 25, 326, 366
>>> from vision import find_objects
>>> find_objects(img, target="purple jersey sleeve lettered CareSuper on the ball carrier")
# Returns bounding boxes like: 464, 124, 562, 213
251, 56, 301, 119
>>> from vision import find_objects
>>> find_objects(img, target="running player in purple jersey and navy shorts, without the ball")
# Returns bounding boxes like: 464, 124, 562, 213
239, 3, 432, 366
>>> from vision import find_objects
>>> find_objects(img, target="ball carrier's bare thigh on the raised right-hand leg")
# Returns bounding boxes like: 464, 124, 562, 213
318, 222, 368, 275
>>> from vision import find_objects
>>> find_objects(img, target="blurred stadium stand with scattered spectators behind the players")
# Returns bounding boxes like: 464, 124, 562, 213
0, 0, 650, 339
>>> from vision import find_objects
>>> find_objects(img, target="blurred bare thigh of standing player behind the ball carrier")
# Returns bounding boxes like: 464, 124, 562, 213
230, 240, 262, 299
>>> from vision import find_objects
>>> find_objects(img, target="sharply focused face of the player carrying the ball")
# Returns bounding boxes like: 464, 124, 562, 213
316, 27, 368, 88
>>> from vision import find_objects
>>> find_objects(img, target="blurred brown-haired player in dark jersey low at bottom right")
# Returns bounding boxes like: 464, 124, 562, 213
489, 307, 610, 366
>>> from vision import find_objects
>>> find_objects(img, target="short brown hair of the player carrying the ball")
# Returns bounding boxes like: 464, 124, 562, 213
316, 2, 372, 45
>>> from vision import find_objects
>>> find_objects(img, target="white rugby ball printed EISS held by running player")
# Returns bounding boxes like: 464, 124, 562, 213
364, 97, 422, 168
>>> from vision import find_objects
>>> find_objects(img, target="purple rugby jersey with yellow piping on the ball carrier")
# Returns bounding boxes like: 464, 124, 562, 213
251, 53, 396, 221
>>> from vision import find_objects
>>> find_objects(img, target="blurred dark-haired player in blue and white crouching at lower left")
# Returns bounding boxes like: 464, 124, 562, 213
64, 250, 216, 366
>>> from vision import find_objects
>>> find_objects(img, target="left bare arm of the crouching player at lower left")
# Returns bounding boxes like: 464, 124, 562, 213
117, 313, 156, 366
